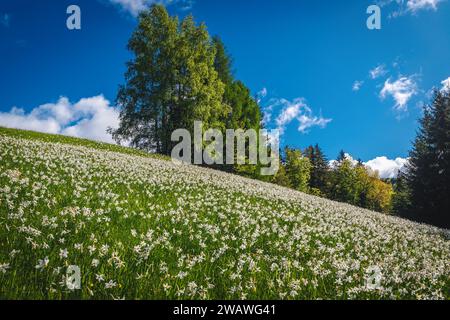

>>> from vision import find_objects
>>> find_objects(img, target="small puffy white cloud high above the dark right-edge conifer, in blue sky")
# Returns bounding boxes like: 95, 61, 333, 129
380, 75, 417, 111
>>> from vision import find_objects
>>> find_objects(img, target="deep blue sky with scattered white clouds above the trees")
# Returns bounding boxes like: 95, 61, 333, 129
0, 0, 450, 176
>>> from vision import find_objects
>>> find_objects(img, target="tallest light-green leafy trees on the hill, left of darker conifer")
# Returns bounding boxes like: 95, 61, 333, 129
111, 5, 229, 155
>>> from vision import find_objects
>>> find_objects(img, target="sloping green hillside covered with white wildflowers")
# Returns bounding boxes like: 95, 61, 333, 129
0, 128, 450, 299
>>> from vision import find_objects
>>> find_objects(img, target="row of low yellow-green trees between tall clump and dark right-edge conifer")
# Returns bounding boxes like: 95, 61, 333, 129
272, 144, 394, 213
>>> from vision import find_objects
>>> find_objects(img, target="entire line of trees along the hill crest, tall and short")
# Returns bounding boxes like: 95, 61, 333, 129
109, 5, 450, 230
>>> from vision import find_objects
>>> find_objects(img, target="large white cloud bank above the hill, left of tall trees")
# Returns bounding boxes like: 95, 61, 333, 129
0, 95, 119, 143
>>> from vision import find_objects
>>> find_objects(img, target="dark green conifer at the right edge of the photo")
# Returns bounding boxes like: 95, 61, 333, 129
402, 91, 450, 228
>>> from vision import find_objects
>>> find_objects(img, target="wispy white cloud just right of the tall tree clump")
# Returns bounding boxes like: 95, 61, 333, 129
269, 98, 332, 135
